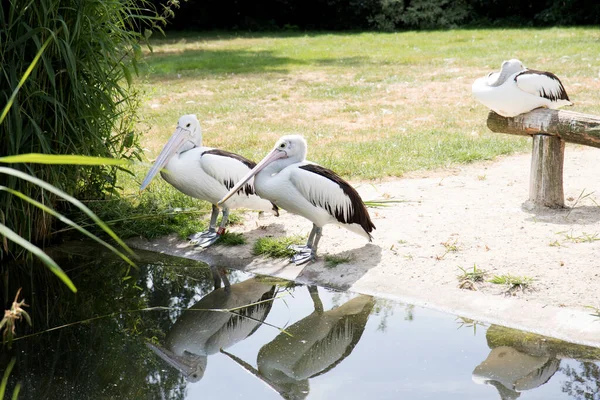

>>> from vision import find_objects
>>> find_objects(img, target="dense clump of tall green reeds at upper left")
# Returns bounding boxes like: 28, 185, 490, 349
0, 0, 169, 258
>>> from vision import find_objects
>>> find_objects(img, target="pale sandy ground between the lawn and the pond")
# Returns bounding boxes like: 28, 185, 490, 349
130, 146, 600, 346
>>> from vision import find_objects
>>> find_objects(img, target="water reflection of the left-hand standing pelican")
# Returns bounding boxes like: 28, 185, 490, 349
148, 278, 276, 382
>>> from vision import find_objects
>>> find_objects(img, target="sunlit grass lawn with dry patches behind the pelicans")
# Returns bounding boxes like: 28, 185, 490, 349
101, 28, 600, 241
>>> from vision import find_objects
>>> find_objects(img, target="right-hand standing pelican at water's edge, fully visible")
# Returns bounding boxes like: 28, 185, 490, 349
218, 135, 375, 265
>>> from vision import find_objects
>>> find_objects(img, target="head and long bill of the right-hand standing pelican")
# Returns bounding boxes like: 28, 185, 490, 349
218, 135, 307, 205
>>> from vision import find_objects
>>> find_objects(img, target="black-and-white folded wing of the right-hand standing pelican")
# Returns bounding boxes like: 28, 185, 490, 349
290, 163, 375, 233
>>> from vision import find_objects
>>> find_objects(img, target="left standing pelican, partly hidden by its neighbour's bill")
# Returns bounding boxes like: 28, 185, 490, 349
140, 115, 279, 247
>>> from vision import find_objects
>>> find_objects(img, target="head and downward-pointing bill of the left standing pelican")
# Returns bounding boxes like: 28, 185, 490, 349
140, 114, 202, 190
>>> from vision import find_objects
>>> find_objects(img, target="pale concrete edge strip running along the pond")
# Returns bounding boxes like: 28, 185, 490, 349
129, 236, 600, 347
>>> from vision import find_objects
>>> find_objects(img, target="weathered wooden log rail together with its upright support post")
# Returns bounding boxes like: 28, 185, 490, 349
487, 108, 600, 208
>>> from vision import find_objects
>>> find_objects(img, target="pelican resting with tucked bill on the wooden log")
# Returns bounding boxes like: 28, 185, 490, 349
471, 59, 573, 117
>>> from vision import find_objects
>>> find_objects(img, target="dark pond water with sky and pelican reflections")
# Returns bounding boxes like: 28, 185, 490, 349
0, 251, 600, 400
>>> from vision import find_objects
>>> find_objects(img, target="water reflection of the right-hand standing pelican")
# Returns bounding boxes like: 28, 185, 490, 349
222, 287, 375, 399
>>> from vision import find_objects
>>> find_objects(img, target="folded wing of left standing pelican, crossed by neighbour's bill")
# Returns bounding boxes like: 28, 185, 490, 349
200, 149, 256, 195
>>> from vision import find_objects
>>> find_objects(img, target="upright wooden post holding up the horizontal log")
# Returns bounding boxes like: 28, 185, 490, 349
526, 134, 565, 208
